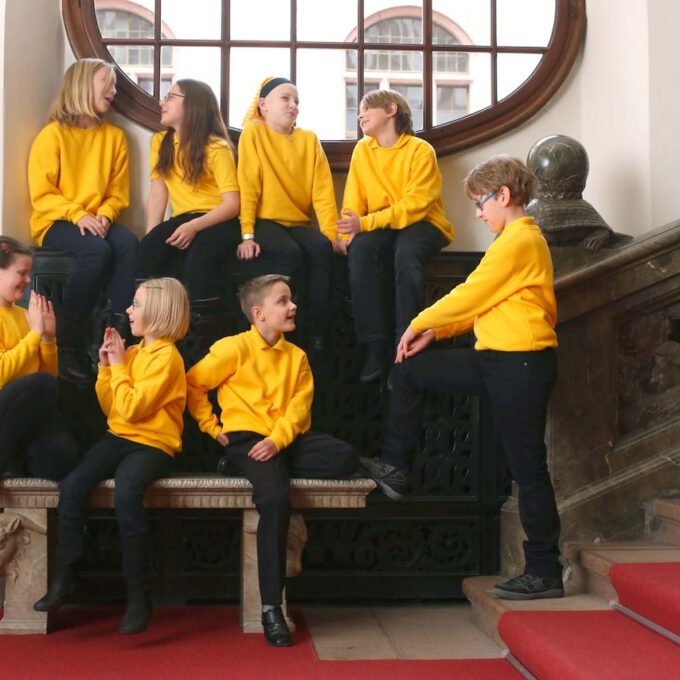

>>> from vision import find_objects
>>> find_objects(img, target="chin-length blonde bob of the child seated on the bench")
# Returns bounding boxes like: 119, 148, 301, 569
139, 276, 190, 342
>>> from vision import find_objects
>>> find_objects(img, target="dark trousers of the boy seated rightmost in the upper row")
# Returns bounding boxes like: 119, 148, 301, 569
347, 222, 446, 344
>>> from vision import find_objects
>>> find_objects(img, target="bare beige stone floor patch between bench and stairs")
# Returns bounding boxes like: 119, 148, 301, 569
302, 602, 502, 660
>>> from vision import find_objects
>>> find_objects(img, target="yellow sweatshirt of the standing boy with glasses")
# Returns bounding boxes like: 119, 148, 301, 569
411, 217, 557, 352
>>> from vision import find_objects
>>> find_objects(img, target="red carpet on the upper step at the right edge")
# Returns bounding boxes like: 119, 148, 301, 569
609, 562, 680, 635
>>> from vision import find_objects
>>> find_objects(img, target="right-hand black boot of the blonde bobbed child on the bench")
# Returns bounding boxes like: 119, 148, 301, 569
120, 534, 152, 634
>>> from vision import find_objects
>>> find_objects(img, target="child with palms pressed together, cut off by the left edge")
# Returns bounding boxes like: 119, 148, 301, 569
0, 236, 77, 480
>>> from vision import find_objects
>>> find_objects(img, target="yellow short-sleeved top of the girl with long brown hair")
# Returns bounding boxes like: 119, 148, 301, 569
149, 132, 238, 217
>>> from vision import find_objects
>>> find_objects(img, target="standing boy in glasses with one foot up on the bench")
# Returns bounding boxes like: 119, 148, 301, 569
361, 156, 564, 600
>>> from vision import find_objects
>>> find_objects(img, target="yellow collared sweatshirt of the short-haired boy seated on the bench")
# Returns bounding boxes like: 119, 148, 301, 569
187, 326, 314, 451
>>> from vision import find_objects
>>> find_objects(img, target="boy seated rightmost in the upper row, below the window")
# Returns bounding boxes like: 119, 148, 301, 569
338, 90, 453, 382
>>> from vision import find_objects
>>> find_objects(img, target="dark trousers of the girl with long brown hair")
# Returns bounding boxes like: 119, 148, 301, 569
137, 213, 241, 300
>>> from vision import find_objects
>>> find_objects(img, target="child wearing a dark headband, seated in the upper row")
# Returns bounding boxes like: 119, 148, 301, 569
237, 78, 339, 370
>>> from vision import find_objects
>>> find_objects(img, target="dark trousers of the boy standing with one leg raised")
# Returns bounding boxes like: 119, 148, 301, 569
382, 349, 562, 578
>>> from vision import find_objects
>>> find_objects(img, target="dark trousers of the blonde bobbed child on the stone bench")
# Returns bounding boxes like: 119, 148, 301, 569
57, 432, 174, 567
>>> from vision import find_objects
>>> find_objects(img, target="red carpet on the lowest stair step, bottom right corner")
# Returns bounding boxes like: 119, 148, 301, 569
498, 611, 680, 680
